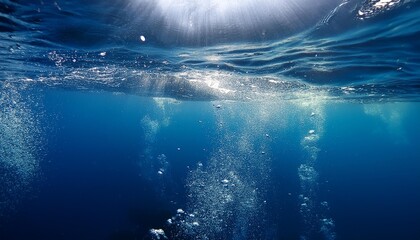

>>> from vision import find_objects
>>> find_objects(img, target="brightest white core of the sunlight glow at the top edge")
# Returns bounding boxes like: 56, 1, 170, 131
152, 0, 296, 34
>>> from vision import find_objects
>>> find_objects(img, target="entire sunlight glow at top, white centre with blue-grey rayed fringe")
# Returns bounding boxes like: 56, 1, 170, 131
131, 0, 341, 44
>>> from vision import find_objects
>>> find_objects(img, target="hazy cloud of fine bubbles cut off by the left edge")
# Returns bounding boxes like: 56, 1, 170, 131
0, 83, 39, 216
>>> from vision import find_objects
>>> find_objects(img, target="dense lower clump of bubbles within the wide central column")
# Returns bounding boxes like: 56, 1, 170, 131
179, 156, 258, 239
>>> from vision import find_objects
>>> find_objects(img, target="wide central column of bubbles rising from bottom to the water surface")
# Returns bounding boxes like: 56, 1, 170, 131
169, 102, 276, 239
